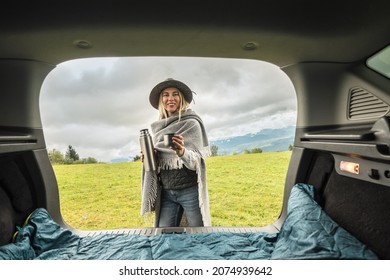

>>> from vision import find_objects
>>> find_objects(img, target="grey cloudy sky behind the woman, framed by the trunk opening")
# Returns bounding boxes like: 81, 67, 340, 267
40, 57, 296, 162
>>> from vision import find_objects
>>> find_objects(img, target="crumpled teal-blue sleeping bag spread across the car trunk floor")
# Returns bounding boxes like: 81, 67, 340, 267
0, 184, 377, 260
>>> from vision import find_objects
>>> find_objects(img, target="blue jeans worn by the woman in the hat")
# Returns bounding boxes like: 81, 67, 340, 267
158, 185, 203, 227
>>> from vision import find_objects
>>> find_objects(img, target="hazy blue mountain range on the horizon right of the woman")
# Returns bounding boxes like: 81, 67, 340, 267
210, 126, 295, 155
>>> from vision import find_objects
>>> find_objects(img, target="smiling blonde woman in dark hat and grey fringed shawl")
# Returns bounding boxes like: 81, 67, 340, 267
141, 79, 211, 227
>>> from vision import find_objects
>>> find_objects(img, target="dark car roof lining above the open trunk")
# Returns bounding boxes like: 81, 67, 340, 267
0, 0, 390, 67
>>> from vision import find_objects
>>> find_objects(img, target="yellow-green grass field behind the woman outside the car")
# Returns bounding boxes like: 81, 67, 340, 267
53, 152, 291, 230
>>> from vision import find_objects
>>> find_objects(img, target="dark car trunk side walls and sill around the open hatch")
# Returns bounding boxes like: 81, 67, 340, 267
0, 58, 390, 259
